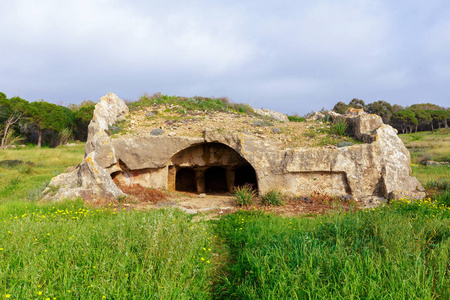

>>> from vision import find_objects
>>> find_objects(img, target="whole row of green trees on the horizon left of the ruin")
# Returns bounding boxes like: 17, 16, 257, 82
0, 92, 95, 149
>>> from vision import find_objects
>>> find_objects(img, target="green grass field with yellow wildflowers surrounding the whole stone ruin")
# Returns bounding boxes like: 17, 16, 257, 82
0, 129, 450, 299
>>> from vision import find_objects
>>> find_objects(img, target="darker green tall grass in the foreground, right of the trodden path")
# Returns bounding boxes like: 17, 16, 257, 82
216, 202, 450, 299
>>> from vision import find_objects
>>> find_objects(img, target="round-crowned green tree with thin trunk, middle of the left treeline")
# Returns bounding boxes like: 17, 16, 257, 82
27, 100, 74, 148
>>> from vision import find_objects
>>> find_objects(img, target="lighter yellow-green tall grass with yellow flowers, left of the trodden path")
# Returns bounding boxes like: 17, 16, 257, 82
0, 203, 212, 299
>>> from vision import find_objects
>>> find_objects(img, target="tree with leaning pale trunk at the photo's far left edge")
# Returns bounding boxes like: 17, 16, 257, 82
0, 93, 28, 149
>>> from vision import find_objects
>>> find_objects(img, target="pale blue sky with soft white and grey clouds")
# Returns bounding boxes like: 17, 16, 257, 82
0, 0, 450, 115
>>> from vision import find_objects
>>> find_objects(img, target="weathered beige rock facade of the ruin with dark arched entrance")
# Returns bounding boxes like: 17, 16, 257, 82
45, 93, 425, 205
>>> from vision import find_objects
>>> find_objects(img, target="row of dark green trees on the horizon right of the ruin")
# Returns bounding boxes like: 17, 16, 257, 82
333, 98, 450, 133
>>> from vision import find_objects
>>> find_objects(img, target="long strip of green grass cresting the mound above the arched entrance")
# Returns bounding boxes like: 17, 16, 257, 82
128, 93, 253, 114
